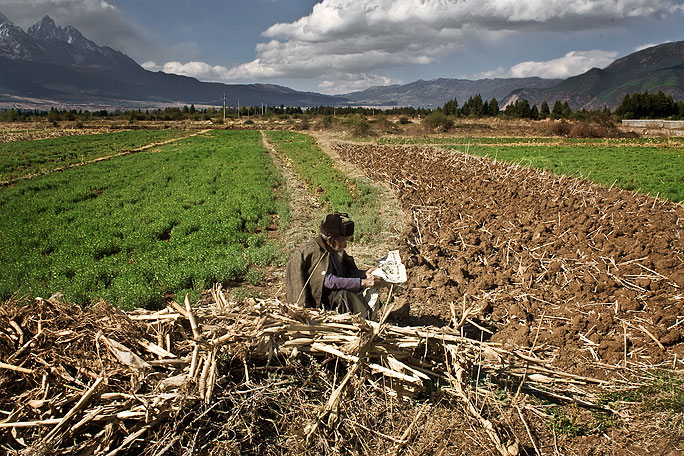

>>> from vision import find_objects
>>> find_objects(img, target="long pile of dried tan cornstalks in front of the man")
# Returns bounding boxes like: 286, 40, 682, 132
0, 288, 620, 456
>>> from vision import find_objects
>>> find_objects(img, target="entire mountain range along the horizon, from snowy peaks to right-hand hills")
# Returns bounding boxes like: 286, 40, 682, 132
0, 14, 684, 109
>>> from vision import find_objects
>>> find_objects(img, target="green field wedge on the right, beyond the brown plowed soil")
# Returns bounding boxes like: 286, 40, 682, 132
379, 138, 684, 202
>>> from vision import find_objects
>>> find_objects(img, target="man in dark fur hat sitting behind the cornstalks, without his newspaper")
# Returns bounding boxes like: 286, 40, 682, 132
285, 212, 382, 318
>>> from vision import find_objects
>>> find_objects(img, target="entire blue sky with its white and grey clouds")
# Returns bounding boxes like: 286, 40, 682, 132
0, 0, 684, 93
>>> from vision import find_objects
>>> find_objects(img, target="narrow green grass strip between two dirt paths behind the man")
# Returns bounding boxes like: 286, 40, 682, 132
268, 131, 382, 242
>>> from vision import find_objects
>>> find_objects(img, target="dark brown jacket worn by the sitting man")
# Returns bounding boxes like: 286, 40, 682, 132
285, 236, 359, 308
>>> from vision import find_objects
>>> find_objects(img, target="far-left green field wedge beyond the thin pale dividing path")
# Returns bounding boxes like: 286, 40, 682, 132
0, 130, 188, 182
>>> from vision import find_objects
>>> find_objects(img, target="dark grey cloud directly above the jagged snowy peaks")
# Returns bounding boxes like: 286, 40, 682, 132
0, 0, 159, 59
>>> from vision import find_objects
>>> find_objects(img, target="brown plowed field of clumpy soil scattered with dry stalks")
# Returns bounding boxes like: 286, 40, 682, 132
335, 144, 684, 377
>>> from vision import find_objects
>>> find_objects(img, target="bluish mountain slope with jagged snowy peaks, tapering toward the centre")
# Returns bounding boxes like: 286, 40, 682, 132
0, 14, 345, 107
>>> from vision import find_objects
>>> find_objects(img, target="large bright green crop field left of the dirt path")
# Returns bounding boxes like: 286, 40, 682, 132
0, 131, 287, 308
